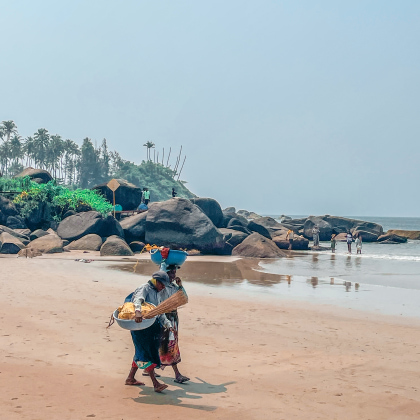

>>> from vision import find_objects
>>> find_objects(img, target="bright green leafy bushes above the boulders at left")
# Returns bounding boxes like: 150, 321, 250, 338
10, 178, 112, 221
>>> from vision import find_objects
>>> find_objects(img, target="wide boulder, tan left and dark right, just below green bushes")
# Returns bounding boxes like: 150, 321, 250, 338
57, 211, 124, 241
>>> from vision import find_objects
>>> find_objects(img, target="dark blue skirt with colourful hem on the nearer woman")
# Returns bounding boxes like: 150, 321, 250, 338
131, 320, 161, 372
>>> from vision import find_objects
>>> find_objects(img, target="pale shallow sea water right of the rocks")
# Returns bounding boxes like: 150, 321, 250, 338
259, 217, 420, 317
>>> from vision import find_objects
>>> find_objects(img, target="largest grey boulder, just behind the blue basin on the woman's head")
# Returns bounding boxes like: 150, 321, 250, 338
146, 198, 223, 253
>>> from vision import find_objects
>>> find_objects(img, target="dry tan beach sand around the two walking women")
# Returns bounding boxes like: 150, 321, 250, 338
0, 253, 420, 420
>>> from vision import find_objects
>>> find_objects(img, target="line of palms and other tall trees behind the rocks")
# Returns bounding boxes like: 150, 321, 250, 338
0, 121, 188, 191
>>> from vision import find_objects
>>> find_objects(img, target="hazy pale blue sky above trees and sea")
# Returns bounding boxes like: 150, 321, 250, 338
0, 0, 420, 216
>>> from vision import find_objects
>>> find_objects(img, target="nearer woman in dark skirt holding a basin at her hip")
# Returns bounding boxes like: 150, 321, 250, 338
125, 271, 173, 392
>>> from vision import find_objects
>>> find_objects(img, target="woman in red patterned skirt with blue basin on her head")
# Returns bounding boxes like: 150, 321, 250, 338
159, 265, 190, 384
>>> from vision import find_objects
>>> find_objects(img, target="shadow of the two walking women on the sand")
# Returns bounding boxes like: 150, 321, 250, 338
133, 377, 235, 411
